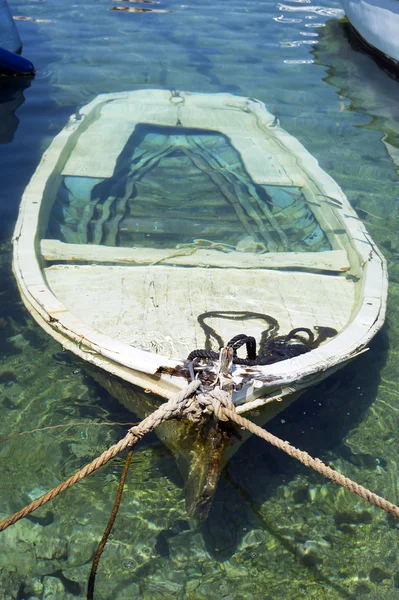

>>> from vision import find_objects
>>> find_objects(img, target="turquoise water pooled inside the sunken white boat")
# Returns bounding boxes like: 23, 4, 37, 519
46, 124, 331, 252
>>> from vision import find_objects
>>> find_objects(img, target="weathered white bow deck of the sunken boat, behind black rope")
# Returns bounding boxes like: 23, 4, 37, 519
45, 265, 355, 359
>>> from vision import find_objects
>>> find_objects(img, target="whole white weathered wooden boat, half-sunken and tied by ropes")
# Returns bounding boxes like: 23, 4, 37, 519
14, 90, 387, 516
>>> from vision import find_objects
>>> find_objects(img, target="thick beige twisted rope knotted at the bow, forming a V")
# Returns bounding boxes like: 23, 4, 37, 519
0, 379, 399, 531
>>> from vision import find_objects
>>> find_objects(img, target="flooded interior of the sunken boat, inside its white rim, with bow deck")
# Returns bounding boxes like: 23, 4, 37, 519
39, 95, 361, 359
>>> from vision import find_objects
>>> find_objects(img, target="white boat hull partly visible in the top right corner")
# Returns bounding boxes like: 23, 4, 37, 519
341, 0, 399, 66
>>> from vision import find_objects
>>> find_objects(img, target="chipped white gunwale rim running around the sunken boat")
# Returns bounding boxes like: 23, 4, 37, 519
13, 90, 387, 412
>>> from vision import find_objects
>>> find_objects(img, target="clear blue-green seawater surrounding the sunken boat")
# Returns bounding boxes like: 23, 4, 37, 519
0, 0, 399, 600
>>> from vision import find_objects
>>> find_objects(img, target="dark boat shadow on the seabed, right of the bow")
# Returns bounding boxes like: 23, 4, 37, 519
202, 326, 388, 556
